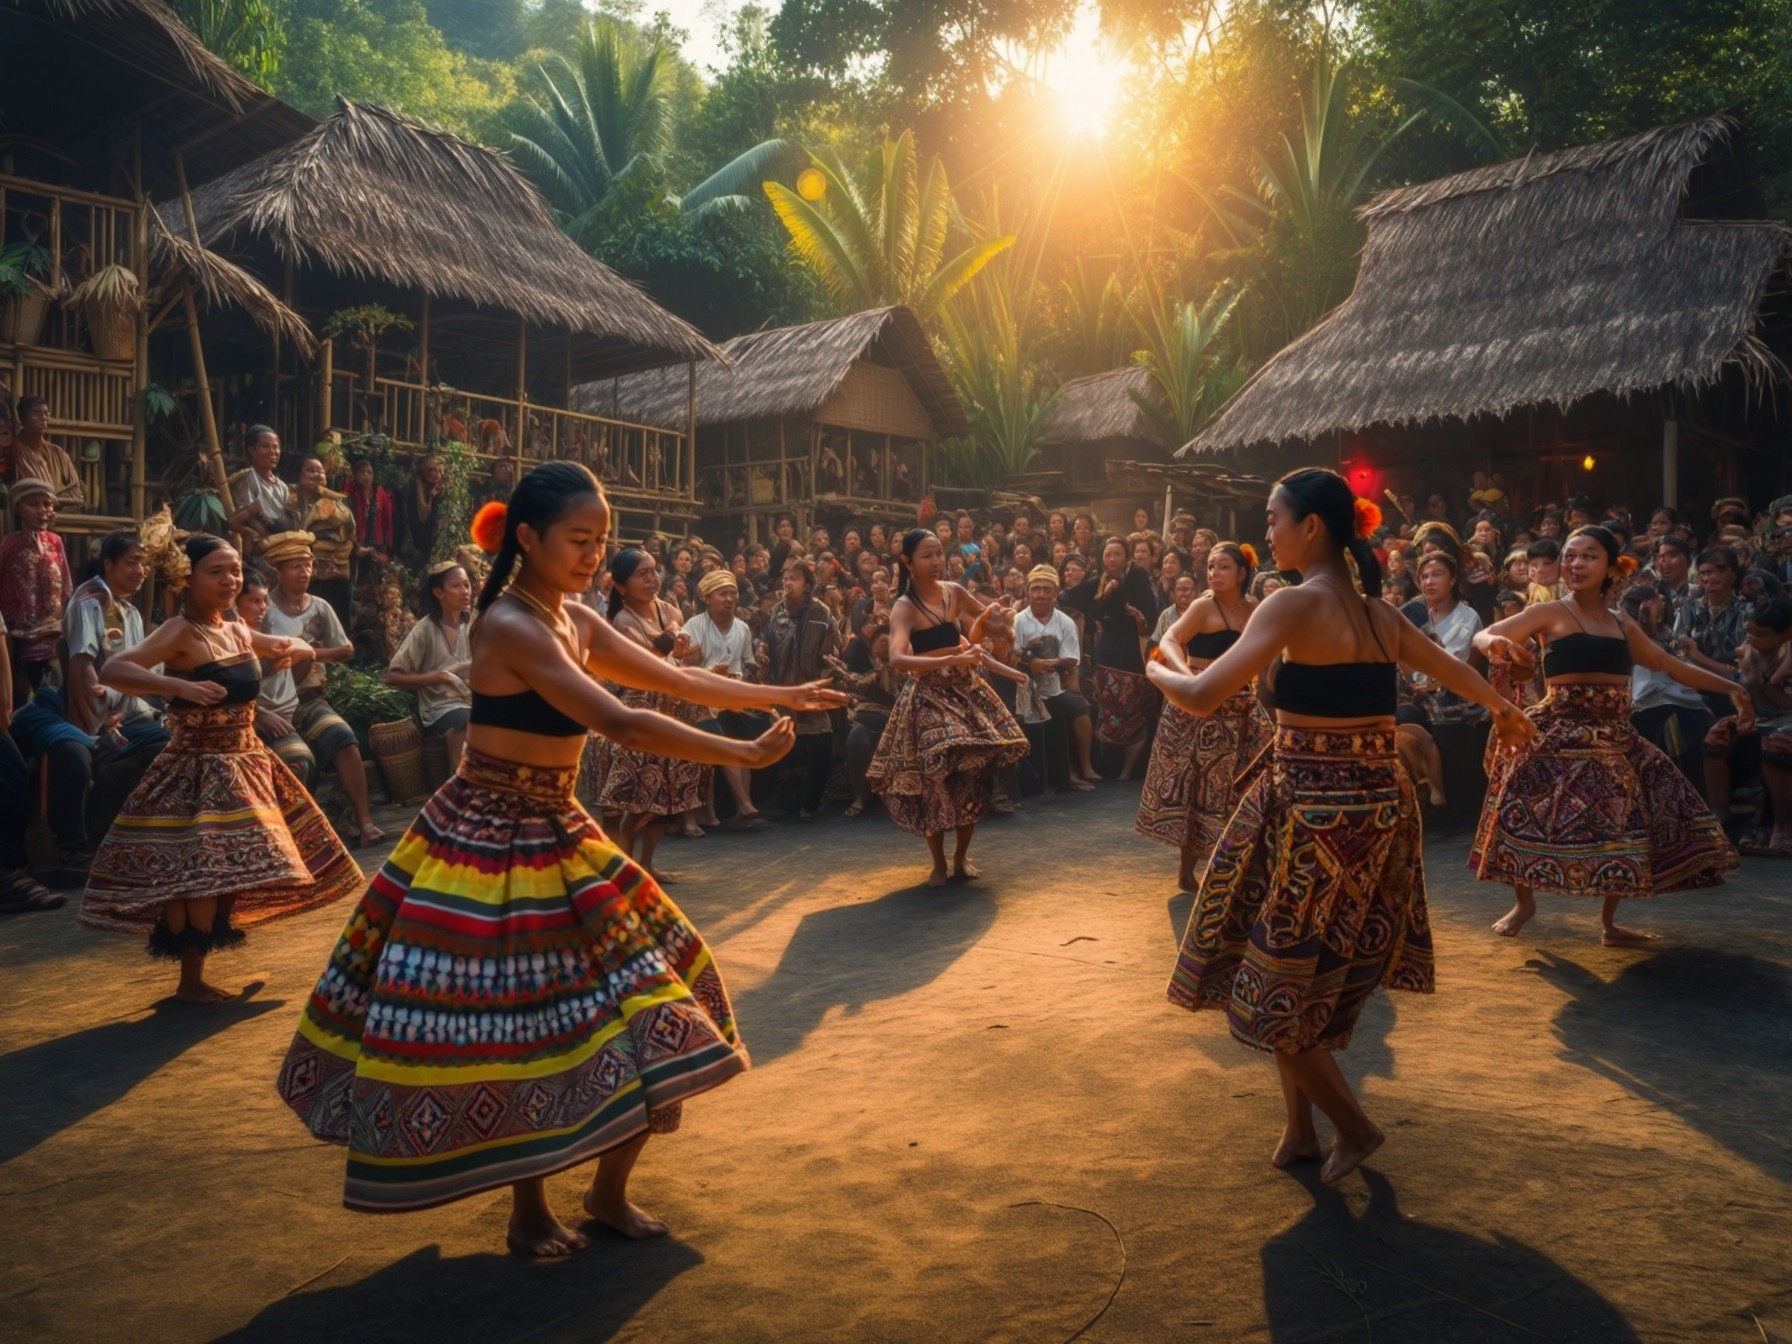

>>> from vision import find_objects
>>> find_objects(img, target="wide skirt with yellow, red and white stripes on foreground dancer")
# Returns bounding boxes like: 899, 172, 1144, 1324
280, 749, 747, 1213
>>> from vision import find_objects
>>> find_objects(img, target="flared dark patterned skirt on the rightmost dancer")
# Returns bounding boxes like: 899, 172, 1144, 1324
1468, 683, 1740, 900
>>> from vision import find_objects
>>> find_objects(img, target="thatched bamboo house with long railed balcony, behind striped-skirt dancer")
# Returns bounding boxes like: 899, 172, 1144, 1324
163, 99, 717, 536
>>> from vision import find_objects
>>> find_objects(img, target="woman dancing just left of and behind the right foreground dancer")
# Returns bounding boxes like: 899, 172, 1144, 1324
1136, 541, 1274, 891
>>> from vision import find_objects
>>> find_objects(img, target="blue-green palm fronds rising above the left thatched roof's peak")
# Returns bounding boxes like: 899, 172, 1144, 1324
507, 18, 674, 247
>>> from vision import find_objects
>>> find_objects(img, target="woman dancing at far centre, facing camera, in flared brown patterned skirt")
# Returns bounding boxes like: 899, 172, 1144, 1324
866, 527, 1027, 887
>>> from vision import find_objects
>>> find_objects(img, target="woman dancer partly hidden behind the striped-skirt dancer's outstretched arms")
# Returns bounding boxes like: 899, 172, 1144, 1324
591, 547, 710, 882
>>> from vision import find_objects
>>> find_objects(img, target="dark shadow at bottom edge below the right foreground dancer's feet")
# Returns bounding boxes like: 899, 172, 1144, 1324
1263, 1165, 1638, 1344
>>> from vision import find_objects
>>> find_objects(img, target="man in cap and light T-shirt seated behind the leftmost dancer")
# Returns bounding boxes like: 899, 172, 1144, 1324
260, 532, 385, 848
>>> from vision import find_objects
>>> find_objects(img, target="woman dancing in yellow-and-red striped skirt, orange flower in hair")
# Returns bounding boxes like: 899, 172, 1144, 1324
280, 462, 844, 1256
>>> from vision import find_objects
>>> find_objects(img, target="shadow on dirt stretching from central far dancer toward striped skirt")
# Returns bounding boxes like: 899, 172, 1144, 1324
735, 883, 996, 1064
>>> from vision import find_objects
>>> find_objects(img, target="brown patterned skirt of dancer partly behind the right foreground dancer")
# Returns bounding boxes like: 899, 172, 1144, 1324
1134, 683, 1276, 862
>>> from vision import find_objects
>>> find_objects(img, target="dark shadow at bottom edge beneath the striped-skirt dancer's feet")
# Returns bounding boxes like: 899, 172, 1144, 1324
222, 1228, 702, 1344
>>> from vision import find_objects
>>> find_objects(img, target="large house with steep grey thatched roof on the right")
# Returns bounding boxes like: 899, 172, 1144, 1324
1181, 116, 1792, 509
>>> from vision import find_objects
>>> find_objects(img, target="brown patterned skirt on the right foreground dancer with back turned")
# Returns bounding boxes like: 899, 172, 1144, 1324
1170, 726, 1434, 1052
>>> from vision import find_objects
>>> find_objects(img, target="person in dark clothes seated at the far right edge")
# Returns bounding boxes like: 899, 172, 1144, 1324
1704, 599, 1792, 855
